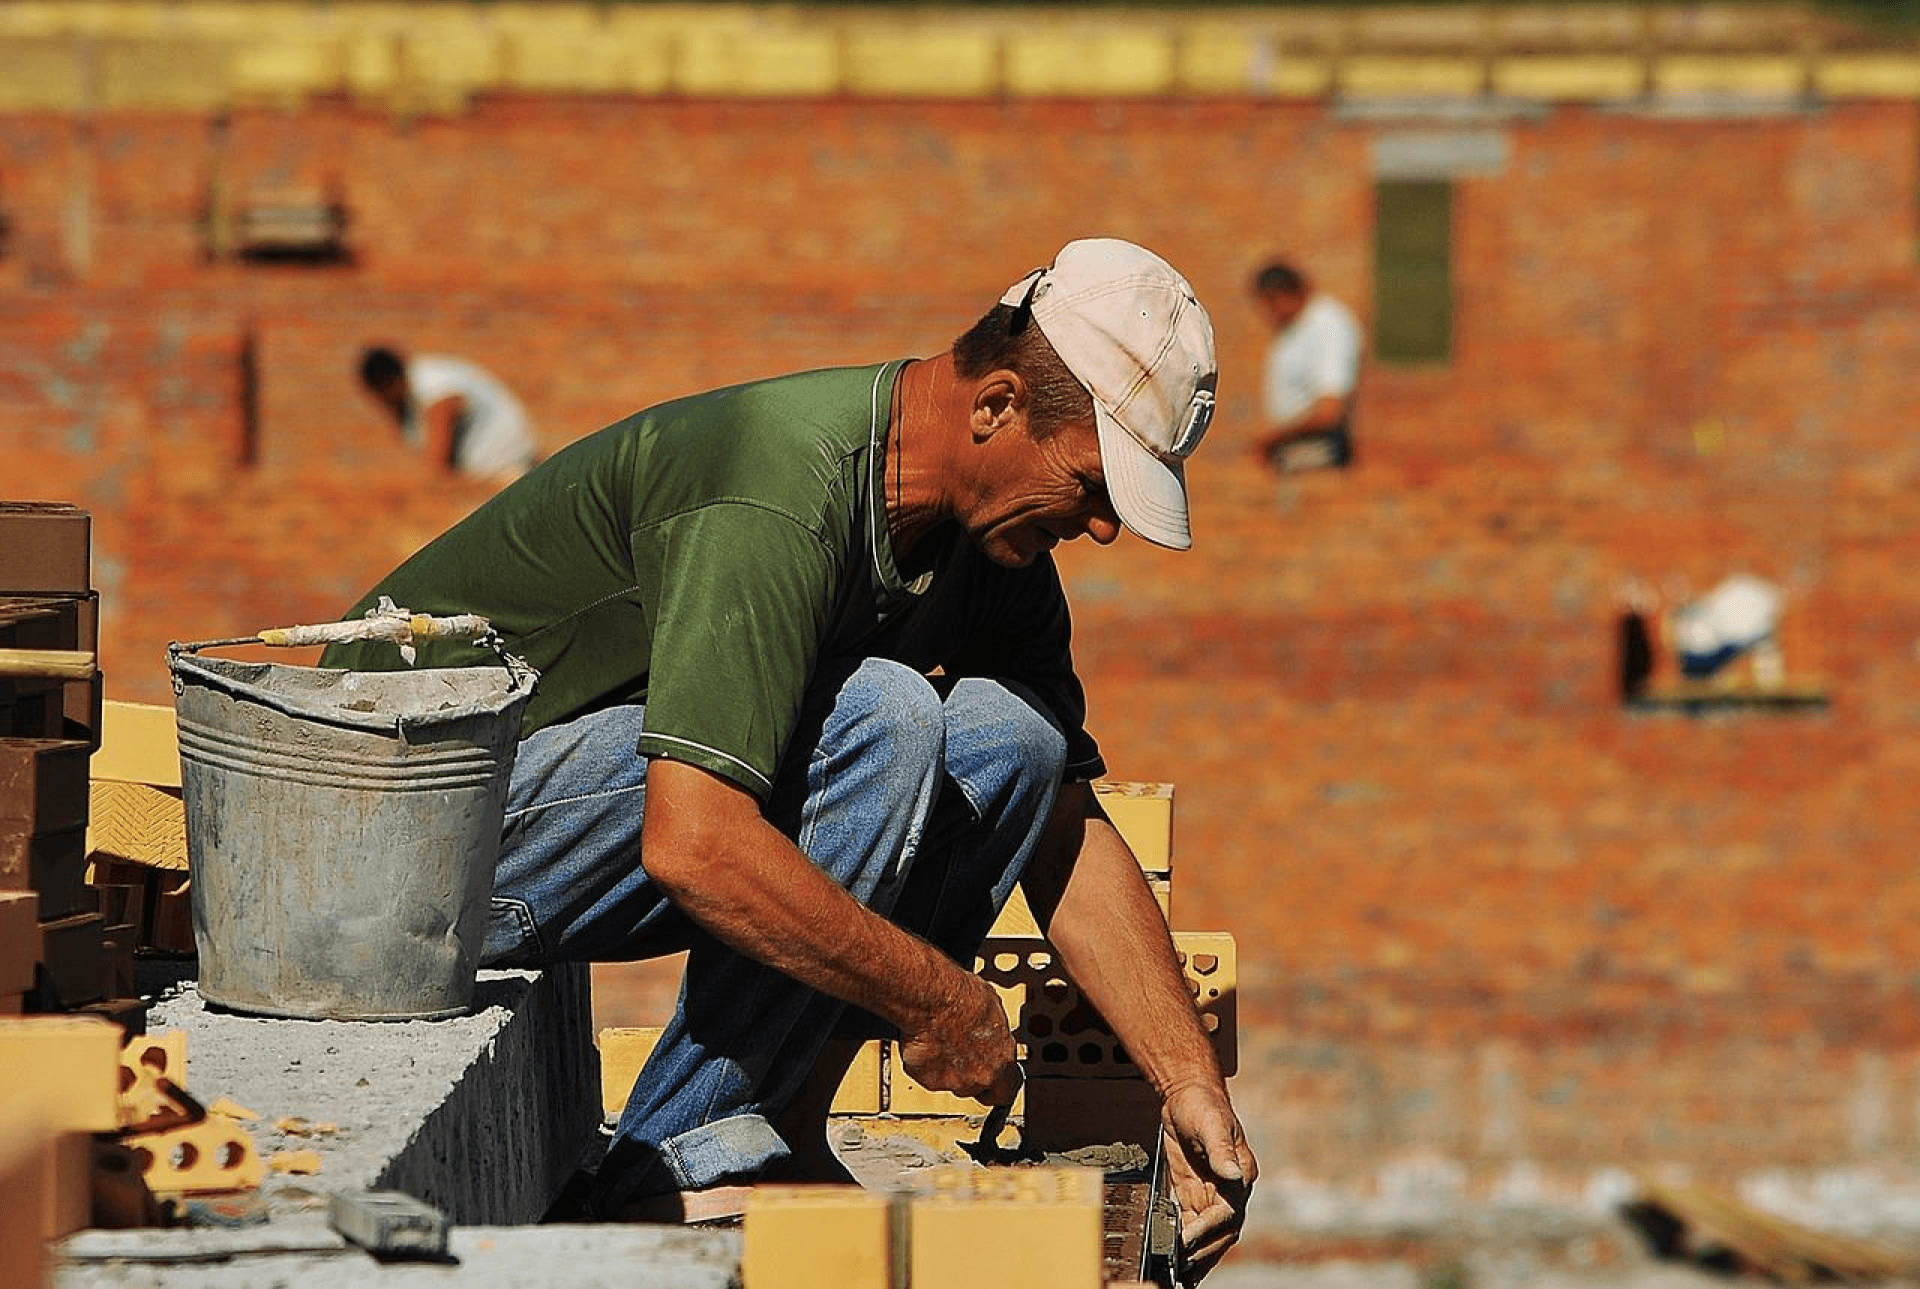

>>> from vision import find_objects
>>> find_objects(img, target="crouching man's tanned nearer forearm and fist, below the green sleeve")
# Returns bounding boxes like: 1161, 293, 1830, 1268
641, 759, 1018, 1103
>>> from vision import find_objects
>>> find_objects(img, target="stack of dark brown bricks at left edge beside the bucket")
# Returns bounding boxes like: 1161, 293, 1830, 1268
0, 501, 146, 1032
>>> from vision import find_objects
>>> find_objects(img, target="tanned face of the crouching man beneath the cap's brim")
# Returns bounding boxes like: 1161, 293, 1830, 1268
968, 423, 1119, 569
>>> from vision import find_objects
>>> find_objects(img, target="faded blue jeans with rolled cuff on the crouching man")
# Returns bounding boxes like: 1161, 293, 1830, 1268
484, 659, 1066, 1212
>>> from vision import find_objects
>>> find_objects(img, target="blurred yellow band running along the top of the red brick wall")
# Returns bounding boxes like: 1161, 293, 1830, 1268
0, 0, 1920, 109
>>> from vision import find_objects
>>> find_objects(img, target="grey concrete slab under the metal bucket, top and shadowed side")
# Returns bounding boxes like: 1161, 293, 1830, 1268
121, 968, 601, 1226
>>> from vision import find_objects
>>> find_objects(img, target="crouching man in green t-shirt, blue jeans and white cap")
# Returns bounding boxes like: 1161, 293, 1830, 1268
324, 238, 1256, 1272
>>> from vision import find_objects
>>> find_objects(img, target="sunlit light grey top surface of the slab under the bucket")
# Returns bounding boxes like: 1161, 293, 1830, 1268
146, 972, 538, 1218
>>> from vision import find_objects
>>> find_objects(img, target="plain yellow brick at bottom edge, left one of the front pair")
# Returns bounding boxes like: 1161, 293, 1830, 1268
739, 1185, 893, 1289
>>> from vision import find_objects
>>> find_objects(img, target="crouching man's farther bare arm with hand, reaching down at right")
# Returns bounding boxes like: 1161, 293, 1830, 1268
1021, 784, 1260, 1279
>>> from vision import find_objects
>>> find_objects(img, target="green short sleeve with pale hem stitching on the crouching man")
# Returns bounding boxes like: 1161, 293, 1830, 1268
632, 501, 841, 801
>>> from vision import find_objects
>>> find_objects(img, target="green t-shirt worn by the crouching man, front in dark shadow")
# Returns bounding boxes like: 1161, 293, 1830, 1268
321, 363, 1104, 799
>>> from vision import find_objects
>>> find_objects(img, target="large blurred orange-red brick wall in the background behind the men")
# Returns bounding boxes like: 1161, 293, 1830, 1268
0, 96, 1920, 1195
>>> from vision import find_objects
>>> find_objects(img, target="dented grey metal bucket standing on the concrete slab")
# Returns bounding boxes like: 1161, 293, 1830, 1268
169, 653, 534, 1020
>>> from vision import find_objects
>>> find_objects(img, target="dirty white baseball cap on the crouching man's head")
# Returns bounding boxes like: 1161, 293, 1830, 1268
1000, 238, 1219, 551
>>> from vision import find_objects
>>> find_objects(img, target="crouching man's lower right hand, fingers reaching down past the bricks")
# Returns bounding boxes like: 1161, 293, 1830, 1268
1160, 1085, 1260, 1285
